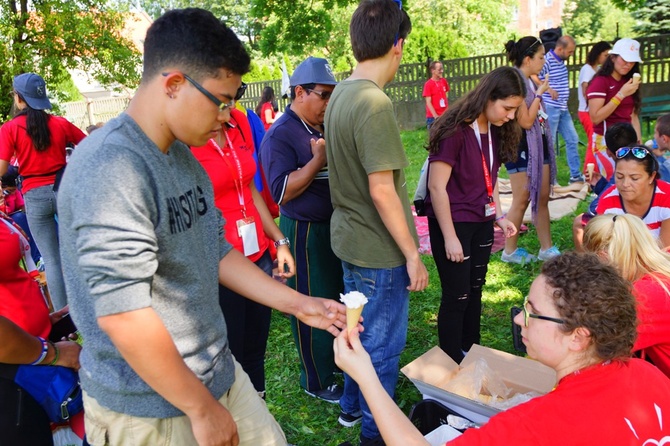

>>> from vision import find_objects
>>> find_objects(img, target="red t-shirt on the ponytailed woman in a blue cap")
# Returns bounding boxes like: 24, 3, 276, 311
0, 115, 86, 194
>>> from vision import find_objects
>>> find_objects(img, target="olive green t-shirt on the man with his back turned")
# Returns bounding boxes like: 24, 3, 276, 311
324, 80, 418, 268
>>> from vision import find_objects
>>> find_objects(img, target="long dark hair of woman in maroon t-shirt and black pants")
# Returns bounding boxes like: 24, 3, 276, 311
428, 67, 526, 162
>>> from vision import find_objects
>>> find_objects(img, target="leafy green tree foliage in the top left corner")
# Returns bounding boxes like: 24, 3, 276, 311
0, 0, 140, 113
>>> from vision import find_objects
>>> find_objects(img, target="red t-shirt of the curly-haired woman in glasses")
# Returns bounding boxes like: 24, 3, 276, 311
448, 359, 670, 446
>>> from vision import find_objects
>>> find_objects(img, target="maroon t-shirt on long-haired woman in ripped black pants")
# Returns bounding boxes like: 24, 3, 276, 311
426, 124, 500, 223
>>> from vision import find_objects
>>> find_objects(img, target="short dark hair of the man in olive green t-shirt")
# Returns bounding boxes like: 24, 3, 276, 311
349, 0, 412, 62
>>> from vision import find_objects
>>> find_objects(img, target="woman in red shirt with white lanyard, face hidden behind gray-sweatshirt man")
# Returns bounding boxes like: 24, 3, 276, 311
193, 109, 295, 396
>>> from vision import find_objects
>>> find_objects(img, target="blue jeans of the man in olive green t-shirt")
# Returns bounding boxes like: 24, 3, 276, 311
340, 261, 409, 438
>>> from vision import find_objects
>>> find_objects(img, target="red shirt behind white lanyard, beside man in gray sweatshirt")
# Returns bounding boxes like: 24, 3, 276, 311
193, 110, 269, 262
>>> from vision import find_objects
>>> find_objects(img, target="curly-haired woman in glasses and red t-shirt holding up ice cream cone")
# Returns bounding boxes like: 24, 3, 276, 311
334, 252, 670, 446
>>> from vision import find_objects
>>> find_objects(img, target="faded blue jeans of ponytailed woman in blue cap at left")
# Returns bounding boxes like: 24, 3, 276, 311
23, 185, 67, 310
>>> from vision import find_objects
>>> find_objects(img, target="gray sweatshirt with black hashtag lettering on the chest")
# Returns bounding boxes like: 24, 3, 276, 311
58, 114, 234, 418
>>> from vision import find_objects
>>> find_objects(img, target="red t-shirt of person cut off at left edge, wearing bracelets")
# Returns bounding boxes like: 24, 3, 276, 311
0, 218, 51, 338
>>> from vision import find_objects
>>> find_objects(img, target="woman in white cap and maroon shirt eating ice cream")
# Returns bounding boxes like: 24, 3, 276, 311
586, 39, 642, 178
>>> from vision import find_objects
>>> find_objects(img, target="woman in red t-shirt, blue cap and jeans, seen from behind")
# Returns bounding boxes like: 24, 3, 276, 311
0, 73, 86, 310
